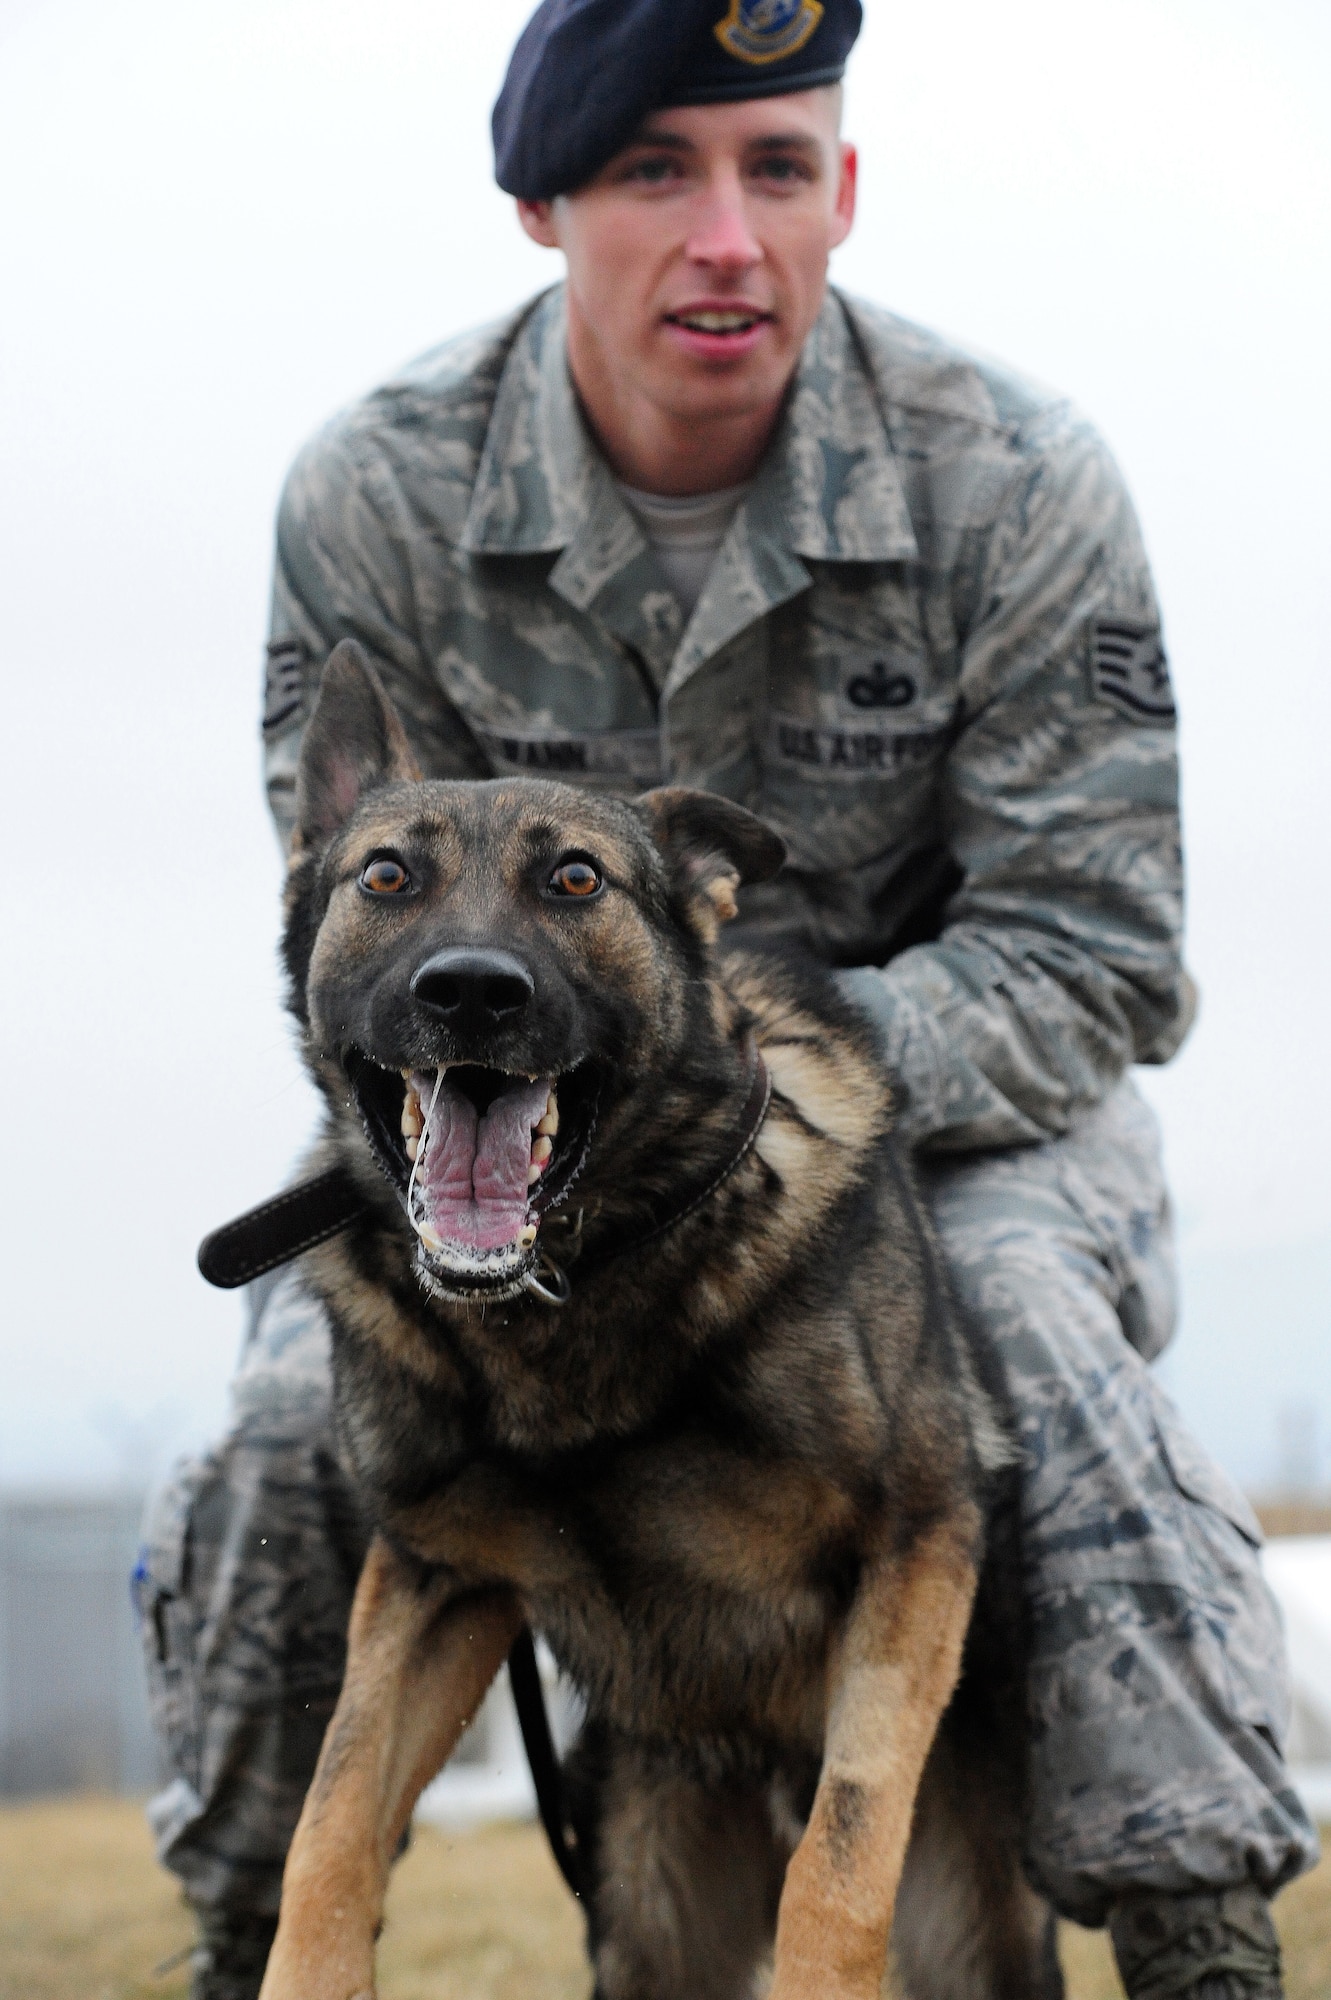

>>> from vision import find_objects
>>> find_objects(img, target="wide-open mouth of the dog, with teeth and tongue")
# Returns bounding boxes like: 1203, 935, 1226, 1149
346, 1056, 598, 1300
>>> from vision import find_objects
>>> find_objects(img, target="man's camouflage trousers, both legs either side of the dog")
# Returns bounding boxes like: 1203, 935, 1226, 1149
140, 1084, 1317, 1924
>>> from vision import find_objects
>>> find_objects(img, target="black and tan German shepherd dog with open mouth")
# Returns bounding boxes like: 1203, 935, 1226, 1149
253, 642, 1061, 2000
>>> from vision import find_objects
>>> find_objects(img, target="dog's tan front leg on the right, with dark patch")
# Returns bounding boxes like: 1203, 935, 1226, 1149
769, 1510, 979, 2000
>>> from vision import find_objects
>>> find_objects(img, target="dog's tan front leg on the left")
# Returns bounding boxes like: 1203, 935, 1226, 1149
260, 1536, 522, 2000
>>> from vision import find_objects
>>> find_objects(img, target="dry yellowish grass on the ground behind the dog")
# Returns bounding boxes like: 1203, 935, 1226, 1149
0, 1798, 1331, 2000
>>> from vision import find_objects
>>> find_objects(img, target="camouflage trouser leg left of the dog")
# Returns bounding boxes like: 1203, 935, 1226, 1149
136, 1286, 366, 1908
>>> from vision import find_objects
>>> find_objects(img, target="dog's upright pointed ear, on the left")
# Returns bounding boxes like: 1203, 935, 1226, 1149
296, 638, 420, 850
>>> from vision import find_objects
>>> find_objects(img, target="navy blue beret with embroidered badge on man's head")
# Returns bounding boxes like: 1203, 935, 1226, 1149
492, 0, 861, 202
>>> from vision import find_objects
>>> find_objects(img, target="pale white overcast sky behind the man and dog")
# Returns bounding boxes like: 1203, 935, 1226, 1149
0, 0, 1331, 1480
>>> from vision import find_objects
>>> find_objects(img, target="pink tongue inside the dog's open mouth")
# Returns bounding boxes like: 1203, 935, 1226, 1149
412, 1074, 550, 1250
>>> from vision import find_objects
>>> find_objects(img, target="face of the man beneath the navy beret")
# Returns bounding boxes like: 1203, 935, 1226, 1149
518, 88, 855, 446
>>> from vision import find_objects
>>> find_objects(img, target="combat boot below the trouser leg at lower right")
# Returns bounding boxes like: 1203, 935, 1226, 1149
1109, 1882, 1285, 2000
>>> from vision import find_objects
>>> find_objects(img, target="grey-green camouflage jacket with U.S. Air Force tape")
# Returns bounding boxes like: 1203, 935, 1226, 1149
264, 288, 1191, 1148
